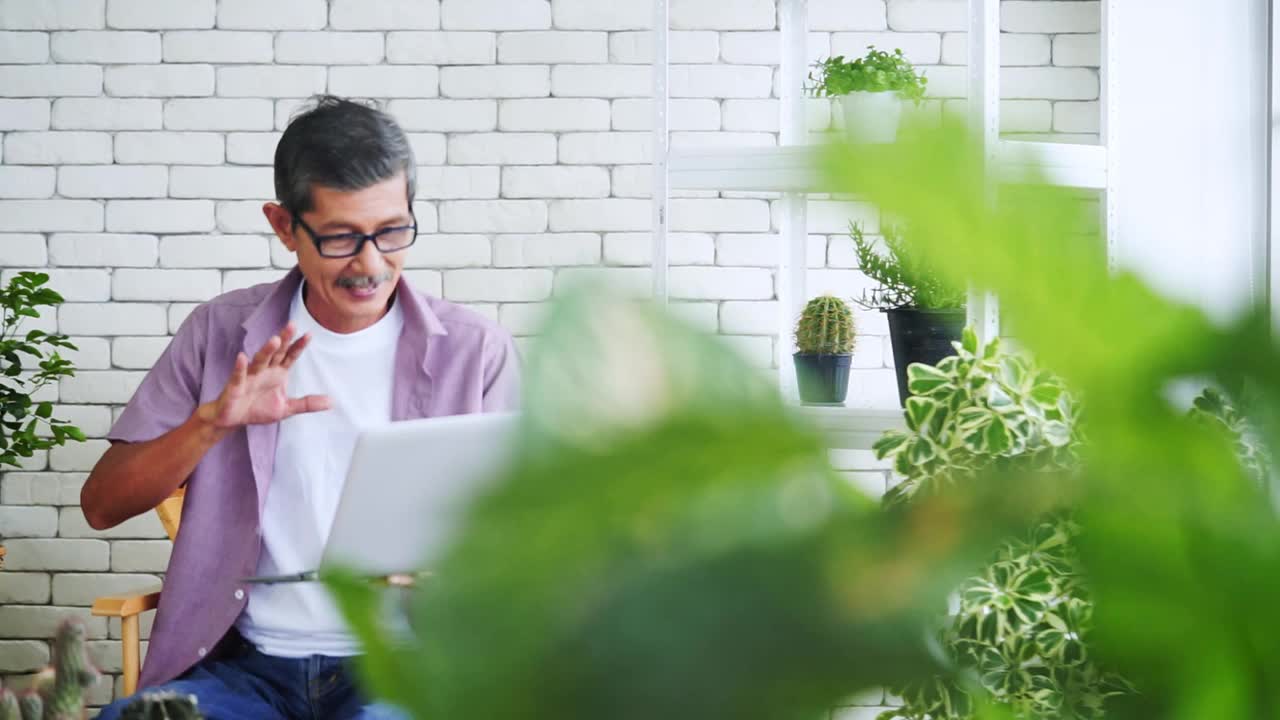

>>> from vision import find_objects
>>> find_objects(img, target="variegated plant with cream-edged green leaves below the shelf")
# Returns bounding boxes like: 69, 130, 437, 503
876, 329, 1128, 720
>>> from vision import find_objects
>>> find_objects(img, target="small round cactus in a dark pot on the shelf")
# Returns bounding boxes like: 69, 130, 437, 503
795, 295, 855, 405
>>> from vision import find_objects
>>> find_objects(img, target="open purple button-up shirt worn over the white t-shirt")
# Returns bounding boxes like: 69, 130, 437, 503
108, 268, 520, 687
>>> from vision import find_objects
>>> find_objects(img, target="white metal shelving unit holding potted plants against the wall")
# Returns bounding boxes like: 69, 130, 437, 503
653, 0, 1119, 450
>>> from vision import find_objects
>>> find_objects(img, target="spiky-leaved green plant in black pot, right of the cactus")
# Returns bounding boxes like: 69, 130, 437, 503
849, 223, 965, 405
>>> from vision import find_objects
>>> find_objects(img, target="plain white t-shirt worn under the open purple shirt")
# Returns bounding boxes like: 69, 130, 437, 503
236, 283, 404, 657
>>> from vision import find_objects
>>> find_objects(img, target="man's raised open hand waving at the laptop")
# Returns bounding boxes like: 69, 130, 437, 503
206, 323, 329, 429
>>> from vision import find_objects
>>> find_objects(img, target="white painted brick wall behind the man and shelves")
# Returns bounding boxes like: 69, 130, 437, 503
0, 0, 1100, 702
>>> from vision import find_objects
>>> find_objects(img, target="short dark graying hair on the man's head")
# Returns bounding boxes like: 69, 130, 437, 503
275, 95, 417, 215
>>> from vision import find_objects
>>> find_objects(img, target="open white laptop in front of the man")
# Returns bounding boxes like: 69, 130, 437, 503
244, 413, 518, 583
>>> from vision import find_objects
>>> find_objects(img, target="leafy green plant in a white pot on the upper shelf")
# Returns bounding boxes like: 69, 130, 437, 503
809, 45, 928, 142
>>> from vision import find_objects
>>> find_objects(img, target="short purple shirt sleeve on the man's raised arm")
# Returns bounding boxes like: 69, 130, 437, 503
106, 306, 209, 442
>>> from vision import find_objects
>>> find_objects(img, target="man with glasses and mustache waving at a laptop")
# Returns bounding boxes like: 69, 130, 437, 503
81, 96, 518, 720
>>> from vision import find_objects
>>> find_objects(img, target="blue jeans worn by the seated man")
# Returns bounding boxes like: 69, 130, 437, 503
99, 630, 408, 720
